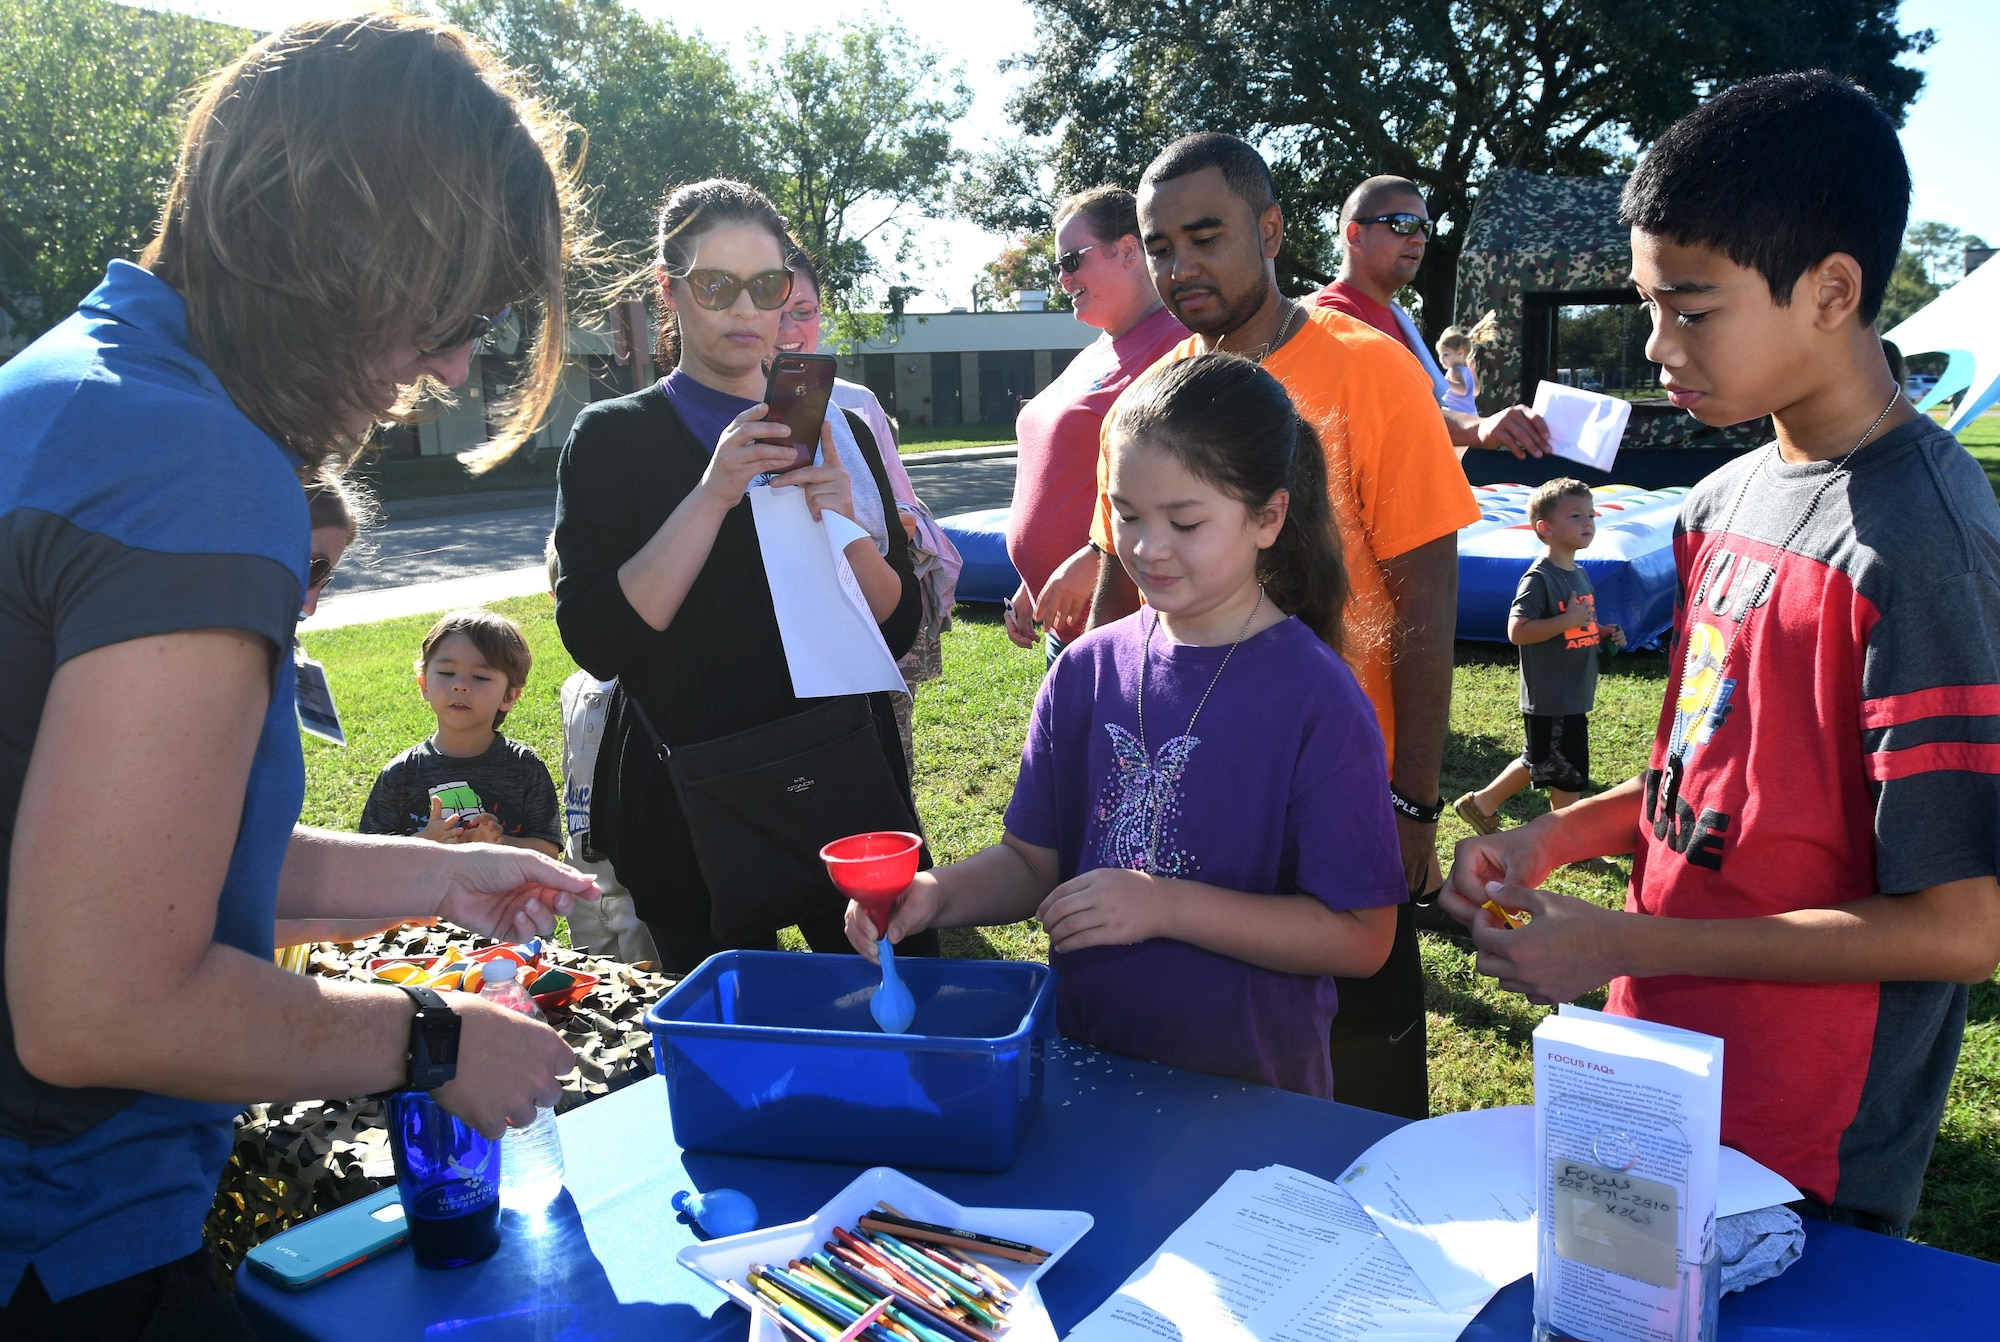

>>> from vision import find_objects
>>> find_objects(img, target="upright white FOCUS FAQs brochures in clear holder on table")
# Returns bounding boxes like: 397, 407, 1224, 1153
1534, 1010, 1722, 1342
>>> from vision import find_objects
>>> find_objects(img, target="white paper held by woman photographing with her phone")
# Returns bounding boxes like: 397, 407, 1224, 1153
748, 484, 904, 698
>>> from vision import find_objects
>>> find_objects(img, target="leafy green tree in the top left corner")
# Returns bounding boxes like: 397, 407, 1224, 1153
0, 0, 250, 336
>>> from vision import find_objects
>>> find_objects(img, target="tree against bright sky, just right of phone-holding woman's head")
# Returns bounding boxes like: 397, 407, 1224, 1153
754, 18, 972, 308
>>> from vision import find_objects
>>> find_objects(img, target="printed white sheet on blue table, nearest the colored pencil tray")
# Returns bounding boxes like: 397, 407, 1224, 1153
1070, 1166, 1486, 1342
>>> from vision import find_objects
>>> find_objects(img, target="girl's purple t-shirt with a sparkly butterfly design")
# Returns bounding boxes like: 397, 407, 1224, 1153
1006, 610, 1408, 1098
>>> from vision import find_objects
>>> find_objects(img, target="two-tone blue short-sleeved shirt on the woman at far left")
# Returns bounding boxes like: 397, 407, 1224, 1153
0, 262, 310, 1300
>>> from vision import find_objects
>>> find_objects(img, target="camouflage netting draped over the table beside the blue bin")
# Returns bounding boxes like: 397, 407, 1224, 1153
204, 928, 674, 1272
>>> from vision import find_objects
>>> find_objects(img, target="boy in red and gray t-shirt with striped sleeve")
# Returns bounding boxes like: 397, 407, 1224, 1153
1444, 72, 2000, 1234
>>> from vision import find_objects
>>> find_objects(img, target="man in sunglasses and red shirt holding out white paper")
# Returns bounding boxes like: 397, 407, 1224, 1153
1308, 176, 1548, 458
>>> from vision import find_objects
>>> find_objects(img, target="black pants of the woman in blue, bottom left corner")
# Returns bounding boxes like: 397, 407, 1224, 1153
0, 1250, 256, 1342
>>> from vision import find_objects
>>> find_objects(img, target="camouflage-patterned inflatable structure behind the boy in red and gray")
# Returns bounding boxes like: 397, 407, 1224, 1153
1454, 168, 1770, 448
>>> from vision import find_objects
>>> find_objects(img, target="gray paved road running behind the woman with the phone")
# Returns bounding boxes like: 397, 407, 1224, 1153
334, 454, 1014, 596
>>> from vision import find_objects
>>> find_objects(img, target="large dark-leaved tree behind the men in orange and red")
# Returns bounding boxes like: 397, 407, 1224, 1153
1010, 0, 1932, 336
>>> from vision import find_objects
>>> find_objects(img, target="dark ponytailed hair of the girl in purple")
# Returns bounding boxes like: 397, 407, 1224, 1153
1112, 354, 1348, 652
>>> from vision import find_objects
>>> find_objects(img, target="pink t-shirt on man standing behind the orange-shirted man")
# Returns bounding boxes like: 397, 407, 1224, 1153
1006, 308, 1188, 640
